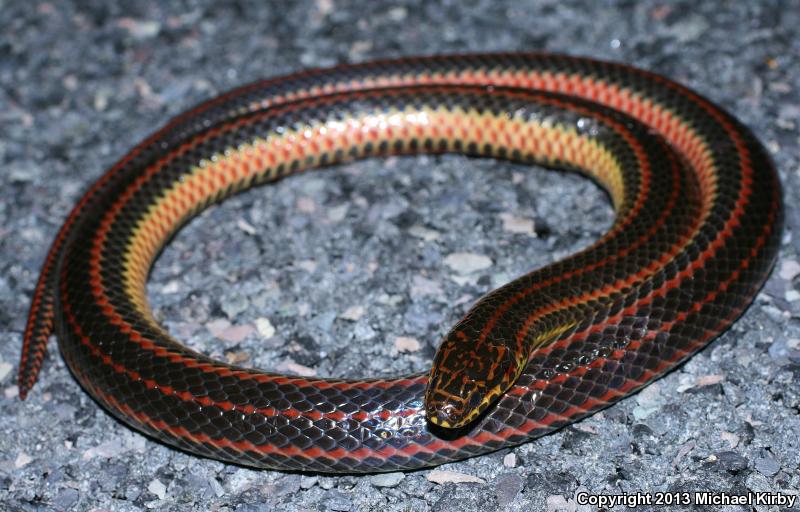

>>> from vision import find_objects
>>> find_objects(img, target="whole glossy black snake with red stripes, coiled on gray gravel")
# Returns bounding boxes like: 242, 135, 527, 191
19, 53, 783, 473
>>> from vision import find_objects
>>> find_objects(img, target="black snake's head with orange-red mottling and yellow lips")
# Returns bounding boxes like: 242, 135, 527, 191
425, 325, 527, 428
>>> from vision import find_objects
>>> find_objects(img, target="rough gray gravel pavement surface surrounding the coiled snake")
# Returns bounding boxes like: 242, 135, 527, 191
0, 0, 800, 512
